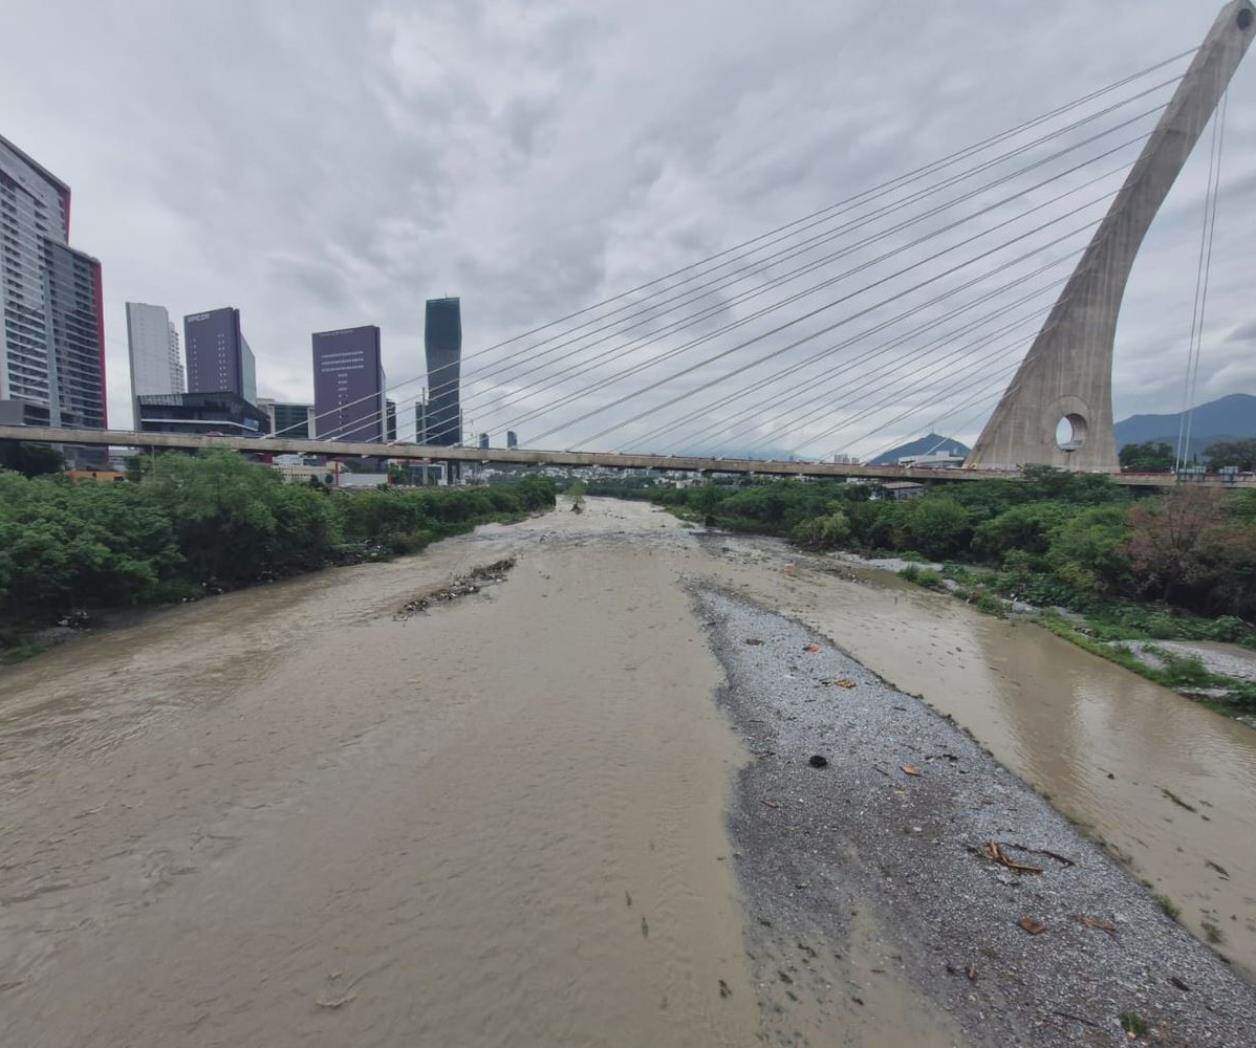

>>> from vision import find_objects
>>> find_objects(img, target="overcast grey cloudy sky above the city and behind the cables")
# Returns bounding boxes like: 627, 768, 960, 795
0, 0, 1256, 455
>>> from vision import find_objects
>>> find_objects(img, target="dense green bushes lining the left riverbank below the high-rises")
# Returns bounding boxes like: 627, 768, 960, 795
0, 451, 554, 661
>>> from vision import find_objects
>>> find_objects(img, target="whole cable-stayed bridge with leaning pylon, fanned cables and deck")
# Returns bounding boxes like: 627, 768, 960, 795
9, 0, 1256, 480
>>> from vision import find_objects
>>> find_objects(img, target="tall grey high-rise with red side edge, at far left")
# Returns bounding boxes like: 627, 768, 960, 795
0, 138, 108, 428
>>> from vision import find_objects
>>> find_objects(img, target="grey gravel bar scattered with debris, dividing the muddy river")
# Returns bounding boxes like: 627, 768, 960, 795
693, 584, 1256, 1047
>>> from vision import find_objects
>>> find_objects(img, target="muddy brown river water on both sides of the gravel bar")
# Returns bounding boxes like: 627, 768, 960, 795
0, 500, 1256, 1045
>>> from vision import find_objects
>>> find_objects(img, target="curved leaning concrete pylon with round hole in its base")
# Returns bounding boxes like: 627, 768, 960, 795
965, 0, 1256, 472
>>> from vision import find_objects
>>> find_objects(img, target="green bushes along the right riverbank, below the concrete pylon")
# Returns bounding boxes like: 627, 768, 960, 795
651, 467, 1256, 715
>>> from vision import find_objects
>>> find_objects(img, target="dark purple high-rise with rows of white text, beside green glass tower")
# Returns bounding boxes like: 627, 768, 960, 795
313, 324, 388, 442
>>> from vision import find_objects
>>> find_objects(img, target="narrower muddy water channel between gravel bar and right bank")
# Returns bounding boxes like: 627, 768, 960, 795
715, 537, 1256, 978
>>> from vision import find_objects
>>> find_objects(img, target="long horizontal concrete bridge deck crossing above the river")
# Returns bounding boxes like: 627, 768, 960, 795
0, 426, 1256, 488
